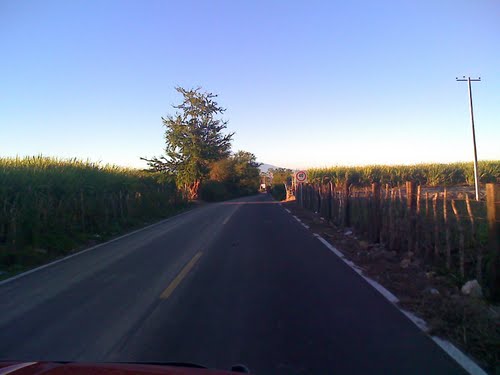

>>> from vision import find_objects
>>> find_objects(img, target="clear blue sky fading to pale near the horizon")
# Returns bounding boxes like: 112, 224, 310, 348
0, 0, 500, 168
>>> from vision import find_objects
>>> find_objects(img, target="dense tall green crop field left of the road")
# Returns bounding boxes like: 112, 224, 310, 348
0, 156, 187, 275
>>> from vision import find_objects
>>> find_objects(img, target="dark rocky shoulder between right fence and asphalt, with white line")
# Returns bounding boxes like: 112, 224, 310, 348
282, 201, 500, 374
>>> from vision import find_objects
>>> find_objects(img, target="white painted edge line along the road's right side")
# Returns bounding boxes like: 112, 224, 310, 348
314, 234, 487, 375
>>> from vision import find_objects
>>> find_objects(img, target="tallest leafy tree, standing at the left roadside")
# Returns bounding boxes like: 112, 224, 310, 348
142, 87, 234, 199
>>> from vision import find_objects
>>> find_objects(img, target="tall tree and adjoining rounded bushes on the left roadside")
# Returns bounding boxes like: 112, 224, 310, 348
143, 87, 259, 201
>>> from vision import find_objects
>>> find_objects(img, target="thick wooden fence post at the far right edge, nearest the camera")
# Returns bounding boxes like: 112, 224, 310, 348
486, 184, 500, 301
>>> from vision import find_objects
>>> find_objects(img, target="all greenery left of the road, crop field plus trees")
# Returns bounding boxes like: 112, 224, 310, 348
0, 87, 259, 278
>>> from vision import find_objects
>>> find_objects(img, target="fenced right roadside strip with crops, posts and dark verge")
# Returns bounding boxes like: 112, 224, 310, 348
287, 161, 500, 374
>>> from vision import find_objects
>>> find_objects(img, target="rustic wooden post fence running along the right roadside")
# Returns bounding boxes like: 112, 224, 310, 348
296, 183, 500, 300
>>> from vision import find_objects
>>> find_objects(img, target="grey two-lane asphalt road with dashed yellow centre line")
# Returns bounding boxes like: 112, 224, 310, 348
0, 194, 465, 374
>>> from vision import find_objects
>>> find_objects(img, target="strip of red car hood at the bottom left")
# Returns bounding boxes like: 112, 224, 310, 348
0, 362, 240, 375
